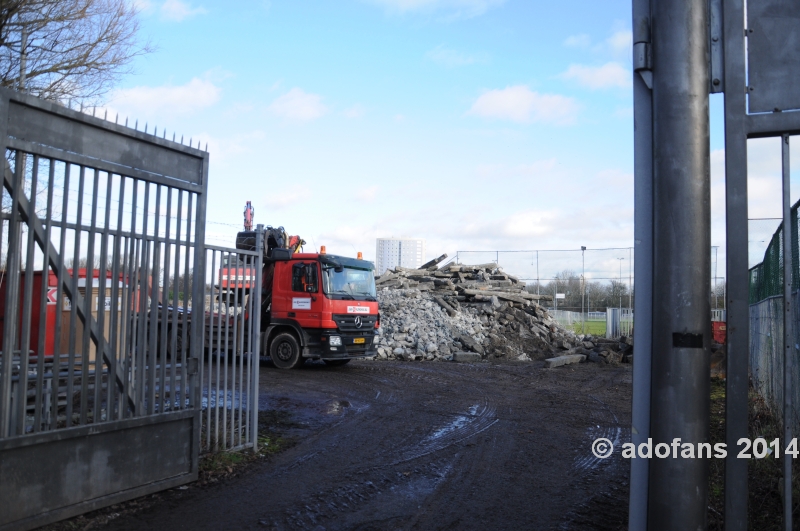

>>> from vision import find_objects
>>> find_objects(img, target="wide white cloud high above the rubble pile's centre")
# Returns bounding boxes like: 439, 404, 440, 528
468, 85, 579, 125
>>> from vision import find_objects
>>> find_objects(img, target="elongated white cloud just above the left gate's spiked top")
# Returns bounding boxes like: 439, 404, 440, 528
106, 77, 222, 118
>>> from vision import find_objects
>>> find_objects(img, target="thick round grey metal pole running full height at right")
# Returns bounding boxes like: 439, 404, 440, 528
647, 0, 711, 531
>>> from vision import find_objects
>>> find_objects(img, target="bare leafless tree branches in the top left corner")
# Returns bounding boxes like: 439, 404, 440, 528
0, 0, 151, 104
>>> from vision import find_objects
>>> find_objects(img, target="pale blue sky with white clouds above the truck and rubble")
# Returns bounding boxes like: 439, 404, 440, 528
107, 0, 792, 278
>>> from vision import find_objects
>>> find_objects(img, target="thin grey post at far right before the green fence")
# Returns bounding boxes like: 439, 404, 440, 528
781, 135, 795, 531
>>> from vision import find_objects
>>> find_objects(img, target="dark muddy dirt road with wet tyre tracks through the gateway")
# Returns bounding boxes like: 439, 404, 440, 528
101, 361, 631, 531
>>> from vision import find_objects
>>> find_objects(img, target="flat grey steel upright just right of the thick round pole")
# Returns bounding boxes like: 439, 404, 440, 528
723, 0, 750, 531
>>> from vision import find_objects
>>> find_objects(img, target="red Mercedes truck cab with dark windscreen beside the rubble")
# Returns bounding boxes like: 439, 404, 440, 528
261, 253, 380, 369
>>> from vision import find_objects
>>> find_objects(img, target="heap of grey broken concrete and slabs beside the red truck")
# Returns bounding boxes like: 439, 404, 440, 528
368, 255, 630, 364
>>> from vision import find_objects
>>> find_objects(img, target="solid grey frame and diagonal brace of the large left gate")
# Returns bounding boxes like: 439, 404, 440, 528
0, 88, 209, 530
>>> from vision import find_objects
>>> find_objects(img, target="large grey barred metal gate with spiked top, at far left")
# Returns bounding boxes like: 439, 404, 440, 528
0, 89, 208, 529
